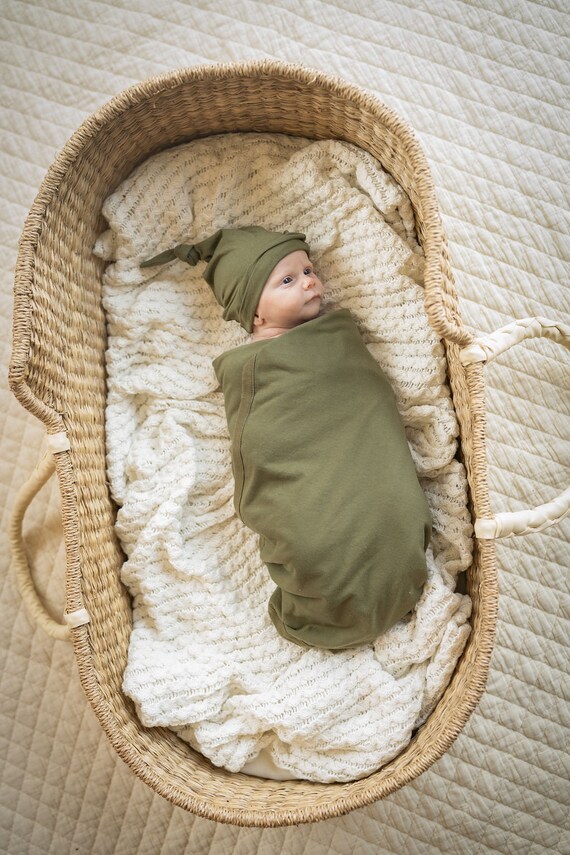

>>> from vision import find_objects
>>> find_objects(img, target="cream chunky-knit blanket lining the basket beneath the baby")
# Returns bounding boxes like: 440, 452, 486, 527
95, 134, 472, 782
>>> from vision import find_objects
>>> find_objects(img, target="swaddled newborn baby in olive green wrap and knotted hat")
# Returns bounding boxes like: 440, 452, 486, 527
141, 226, 431, 650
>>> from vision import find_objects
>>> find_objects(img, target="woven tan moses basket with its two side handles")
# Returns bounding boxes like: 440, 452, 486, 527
10, 61, 564, 826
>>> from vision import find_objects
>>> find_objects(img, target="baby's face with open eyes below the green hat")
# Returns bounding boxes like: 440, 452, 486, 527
253, 249, 323, 337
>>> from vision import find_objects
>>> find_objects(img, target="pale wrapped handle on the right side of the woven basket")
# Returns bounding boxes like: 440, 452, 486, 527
459, 318, 570, 540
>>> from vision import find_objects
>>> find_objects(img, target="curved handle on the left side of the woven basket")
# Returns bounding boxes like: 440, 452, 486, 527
10, 433, 89, 641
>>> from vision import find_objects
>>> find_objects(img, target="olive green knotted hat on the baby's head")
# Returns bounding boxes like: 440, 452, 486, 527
141, 226, 309, 333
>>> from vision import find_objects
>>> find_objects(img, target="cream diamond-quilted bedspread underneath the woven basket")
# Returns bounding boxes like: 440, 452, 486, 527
0, 0, 570, 855
